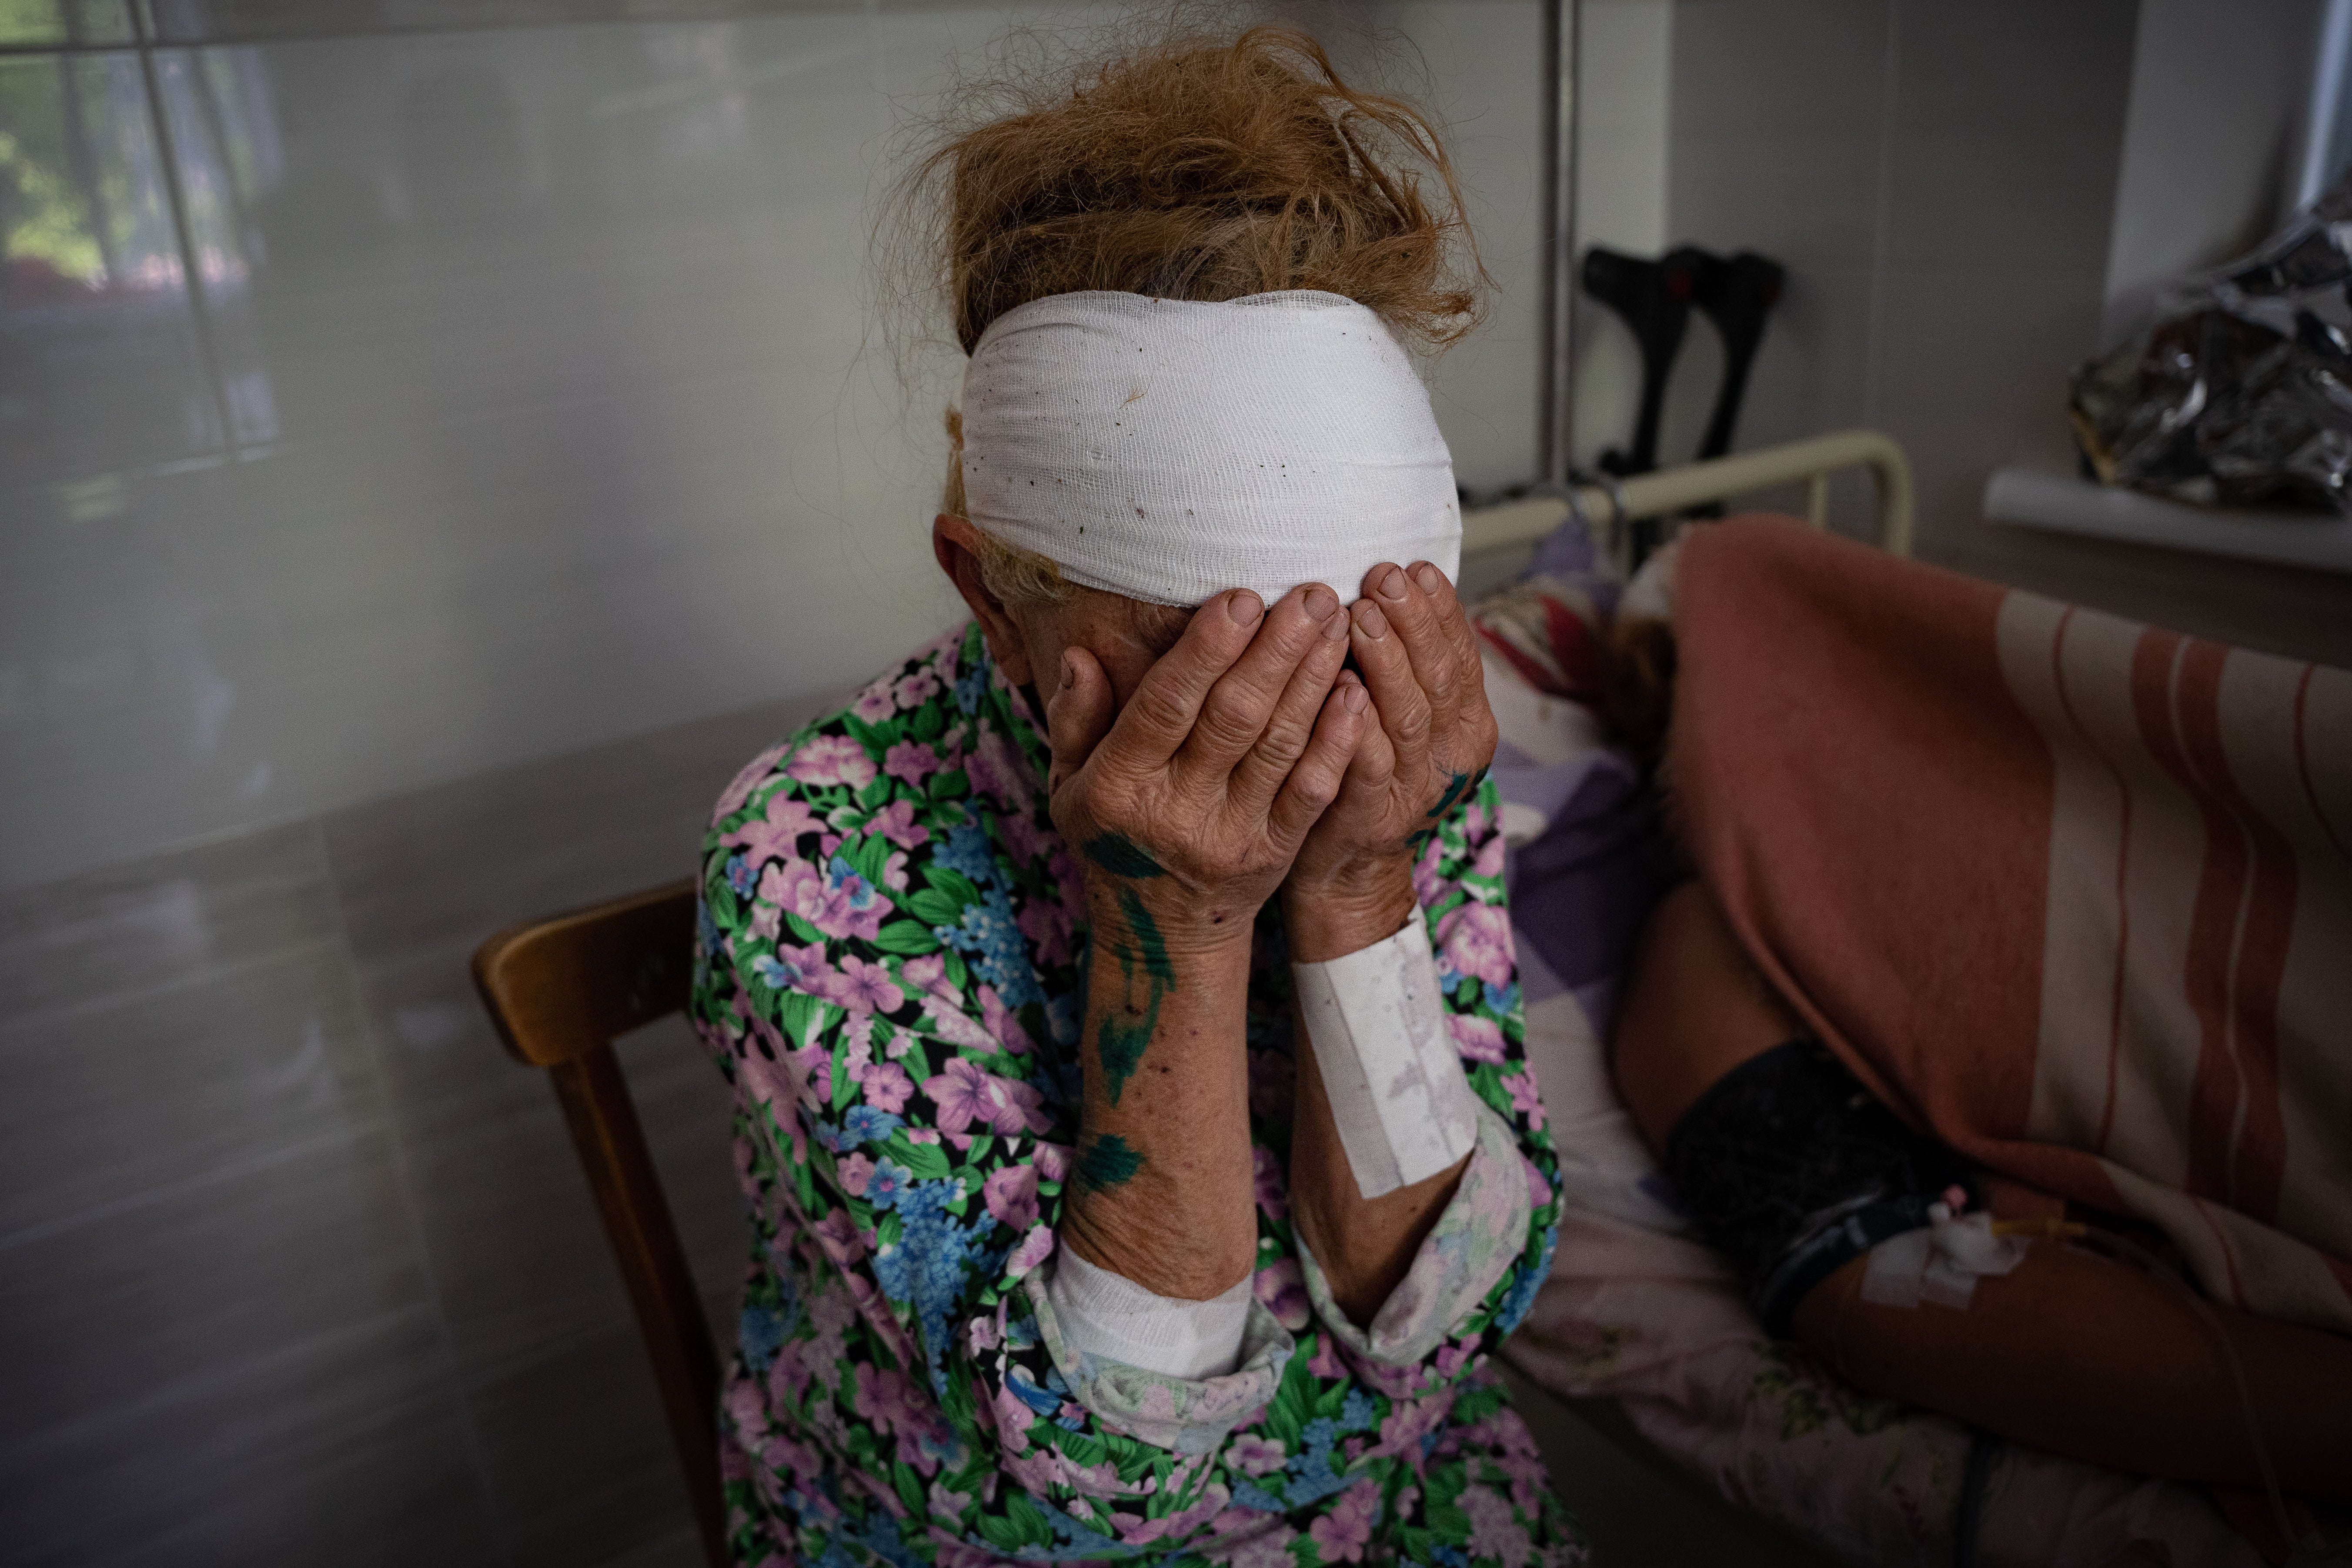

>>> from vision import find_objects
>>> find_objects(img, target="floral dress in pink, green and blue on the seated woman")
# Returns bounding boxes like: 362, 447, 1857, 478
692, 625, 1583, 1568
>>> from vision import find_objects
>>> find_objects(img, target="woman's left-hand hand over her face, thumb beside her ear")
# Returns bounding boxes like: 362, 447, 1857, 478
1047, 585, 1371, 945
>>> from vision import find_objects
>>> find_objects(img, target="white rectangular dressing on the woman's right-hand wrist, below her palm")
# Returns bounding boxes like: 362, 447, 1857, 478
1291, 910, 1477, 1199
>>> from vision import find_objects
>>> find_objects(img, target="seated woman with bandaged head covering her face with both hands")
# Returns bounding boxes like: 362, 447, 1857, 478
694, 30, 1583, 1568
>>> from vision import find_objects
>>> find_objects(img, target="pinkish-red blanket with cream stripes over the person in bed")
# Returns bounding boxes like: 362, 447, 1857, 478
1670, 517, 2352, 1333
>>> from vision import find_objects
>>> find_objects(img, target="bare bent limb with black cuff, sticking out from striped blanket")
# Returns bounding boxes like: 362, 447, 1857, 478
1614, 882, 2352, 1504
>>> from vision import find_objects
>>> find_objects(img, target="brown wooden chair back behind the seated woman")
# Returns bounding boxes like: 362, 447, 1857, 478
473, 879, 727, 1568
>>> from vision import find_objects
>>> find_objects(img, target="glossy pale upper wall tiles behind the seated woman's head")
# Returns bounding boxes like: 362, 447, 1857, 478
0, 0, 1540, 886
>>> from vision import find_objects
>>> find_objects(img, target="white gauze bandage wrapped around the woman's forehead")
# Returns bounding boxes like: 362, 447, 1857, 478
964, 289, 1463, 604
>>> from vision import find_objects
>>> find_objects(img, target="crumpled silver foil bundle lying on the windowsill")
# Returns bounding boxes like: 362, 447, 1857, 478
2070, 174, 2352, 515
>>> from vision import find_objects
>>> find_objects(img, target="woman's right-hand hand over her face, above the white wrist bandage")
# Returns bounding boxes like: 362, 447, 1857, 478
1284, 562, 1496, 900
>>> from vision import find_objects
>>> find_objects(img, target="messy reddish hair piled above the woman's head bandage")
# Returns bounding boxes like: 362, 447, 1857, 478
903, 26, 1484, 353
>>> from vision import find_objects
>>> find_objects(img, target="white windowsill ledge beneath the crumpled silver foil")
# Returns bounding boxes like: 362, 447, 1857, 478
1985, 465, 2352, 571
